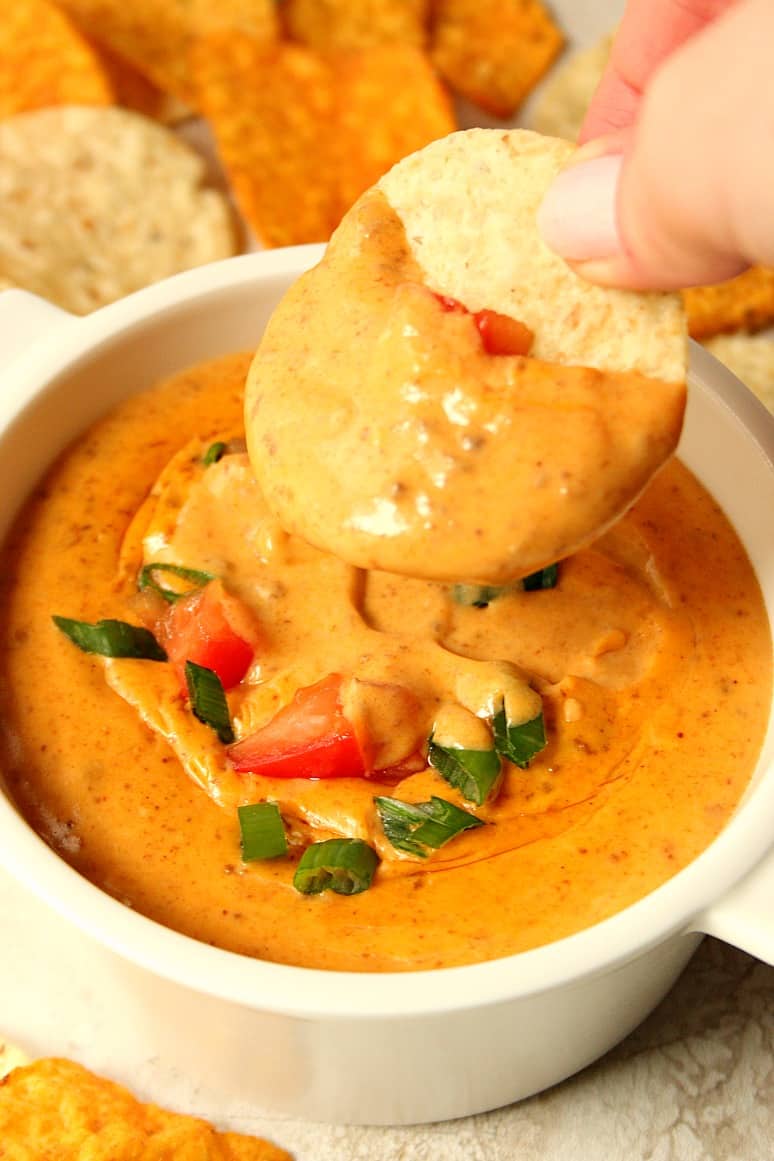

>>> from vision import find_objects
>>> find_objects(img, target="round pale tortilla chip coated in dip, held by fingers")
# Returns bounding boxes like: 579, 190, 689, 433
246, 130, 687, 584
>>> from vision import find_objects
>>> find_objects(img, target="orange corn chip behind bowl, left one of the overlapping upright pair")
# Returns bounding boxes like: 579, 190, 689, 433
191, 35, 339, 246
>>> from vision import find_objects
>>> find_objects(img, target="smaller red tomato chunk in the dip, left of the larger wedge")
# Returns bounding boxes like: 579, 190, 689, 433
158, 581, 255, 690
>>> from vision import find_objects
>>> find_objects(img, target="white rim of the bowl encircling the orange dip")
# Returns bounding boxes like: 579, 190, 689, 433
0, 245, 774, 1021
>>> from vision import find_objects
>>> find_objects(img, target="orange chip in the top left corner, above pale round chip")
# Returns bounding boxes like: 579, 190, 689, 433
0, 0, 114, 117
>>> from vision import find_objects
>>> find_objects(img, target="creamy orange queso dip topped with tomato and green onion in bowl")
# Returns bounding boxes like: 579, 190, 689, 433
0, 131, 772, 972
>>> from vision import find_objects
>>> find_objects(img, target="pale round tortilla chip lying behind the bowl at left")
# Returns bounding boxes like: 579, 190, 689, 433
0, 107, 236, 315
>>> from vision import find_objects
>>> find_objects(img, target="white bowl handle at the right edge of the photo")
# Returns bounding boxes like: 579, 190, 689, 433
692, 851, 774, 966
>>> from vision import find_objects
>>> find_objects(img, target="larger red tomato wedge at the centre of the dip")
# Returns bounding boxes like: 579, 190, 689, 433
229, 673, 366, 778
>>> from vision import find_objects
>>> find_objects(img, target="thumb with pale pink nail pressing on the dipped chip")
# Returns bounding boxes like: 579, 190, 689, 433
538, 0, 774, 290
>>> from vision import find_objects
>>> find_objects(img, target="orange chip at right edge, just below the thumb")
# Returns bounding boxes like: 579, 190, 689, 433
682, 266, 774, 339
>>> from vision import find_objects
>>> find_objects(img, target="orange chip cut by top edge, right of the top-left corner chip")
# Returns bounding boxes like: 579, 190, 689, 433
59, 0, 279, 103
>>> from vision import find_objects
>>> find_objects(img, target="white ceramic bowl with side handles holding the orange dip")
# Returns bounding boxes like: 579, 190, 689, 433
0, 246, 774, 1124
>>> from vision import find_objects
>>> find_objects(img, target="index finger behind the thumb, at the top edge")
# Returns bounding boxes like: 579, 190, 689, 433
578, 0, 738, 143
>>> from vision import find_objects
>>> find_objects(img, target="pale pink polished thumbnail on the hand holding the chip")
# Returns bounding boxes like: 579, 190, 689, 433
537, 153, 623, 262
